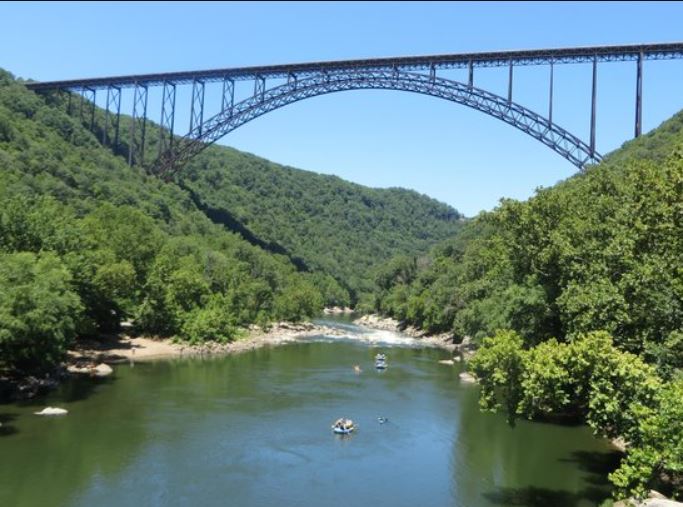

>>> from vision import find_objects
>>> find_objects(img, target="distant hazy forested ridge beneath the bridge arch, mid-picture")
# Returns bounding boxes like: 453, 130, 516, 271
182, 146, 462, 303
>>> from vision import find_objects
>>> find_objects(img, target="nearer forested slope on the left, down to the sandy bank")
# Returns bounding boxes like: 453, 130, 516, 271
0, 73, 333, 374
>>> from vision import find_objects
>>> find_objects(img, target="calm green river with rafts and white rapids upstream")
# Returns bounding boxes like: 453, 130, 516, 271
0, 317, 617, 507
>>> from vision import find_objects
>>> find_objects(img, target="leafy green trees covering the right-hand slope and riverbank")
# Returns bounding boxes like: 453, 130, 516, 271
363, 113, 683, 500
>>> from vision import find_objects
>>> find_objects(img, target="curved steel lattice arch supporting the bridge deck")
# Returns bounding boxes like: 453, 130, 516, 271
151, 70, 601, 178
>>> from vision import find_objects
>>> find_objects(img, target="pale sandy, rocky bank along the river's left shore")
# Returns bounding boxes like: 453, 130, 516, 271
69, 322, 343, 365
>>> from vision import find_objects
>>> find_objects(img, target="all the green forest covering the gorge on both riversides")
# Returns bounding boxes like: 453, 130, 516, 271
0, 60, 683, 495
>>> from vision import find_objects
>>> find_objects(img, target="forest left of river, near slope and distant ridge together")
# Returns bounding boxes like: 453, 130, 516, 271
0, 67, 462, 380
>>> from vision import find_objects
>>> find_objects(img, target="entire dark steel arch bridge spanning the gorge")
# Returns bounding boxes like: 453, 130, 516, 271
27, 43, 683, 179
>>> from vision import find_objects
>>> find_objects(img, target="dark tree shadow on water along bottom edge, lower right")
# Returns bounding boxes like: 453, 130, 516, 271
484, 486, 609, 507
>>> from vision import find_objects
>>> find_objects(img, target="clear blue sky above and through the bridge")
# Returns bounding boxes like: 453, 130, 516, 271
0, 2, 683, 216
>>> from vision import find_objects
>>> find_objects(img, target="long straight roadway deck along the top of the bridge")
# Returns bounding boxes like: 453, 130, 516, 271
27, 42, 683, 91
